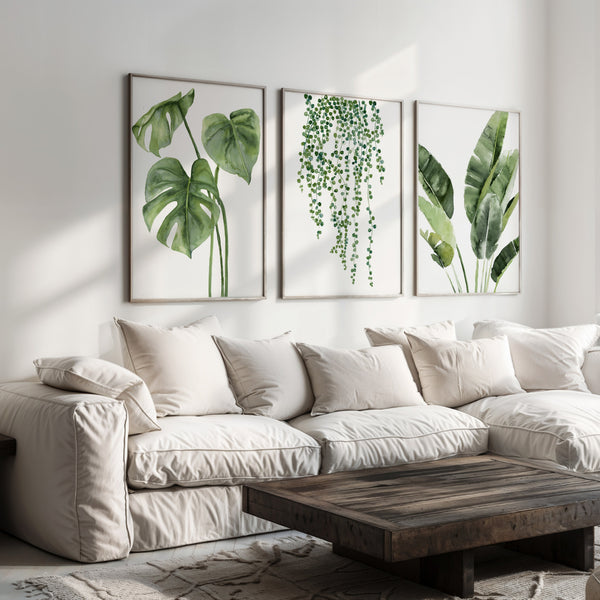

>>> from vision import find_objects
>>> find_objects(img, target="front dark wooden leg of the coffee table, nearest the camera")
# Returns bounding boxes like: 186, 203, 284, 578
333, 544, 475, 598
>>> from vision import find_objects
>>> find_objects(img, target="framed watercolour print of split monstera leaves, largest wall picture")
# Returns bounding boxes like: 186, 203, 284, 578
129, 74, 265, 302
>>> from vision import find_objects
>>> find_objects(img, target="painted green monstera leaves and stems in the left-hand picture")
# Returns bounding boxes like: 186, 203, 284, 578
132, 89, 260, 297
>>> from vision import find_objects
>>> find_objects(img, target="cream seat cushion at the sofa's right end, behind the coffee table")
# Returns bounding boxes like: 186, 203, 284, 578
460, 390, 600, 473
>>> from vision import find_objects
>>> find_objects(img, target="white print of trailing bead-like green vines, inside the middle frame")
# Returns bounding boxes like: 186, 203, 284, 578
284, 90, 401, 297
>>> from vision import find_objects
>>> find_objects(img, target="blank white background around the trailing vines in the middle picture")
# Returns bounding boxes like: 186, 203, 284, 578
282, 90, 402, 298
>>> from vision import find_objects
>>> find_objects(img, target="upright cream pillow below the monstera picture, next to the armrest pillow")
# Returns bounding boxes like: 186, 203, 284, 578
115, 317, 241, 417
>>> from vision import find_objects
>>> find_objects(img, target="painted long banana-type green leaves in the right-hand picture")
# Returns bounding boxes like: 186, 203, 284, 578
418, 111, 520, 294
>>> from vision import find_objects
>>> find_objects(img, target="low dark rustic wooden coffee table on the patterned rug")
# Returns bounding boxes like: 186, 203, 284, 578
243, 455, 600, 597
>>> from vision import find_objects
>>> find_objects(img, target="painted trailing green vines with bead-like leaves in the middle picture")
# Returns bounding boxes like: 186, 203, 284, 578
297, 94, 385, 287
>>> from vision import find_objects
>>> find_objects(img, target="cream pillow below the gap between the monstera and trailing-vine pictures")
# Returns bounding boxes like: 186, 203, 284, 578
214, 332, 314, 421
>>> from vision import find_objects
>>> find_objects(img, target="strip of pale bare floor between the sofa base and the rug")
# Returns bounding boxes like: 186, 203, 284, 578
0, 531, 292, 600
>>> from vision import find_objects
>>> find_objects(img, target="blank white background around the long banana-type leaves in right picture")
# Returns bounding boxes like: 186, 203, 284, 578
415, 102, 522, 295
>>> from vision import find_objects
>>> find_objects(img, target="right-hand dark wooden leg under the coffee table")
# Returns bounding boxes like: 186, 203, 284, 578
506, 527, 594, 571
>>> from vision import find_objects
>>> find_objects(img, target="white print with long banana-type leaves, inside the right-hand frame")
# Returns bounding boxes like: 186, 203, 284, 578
416, 103, 520, 294
